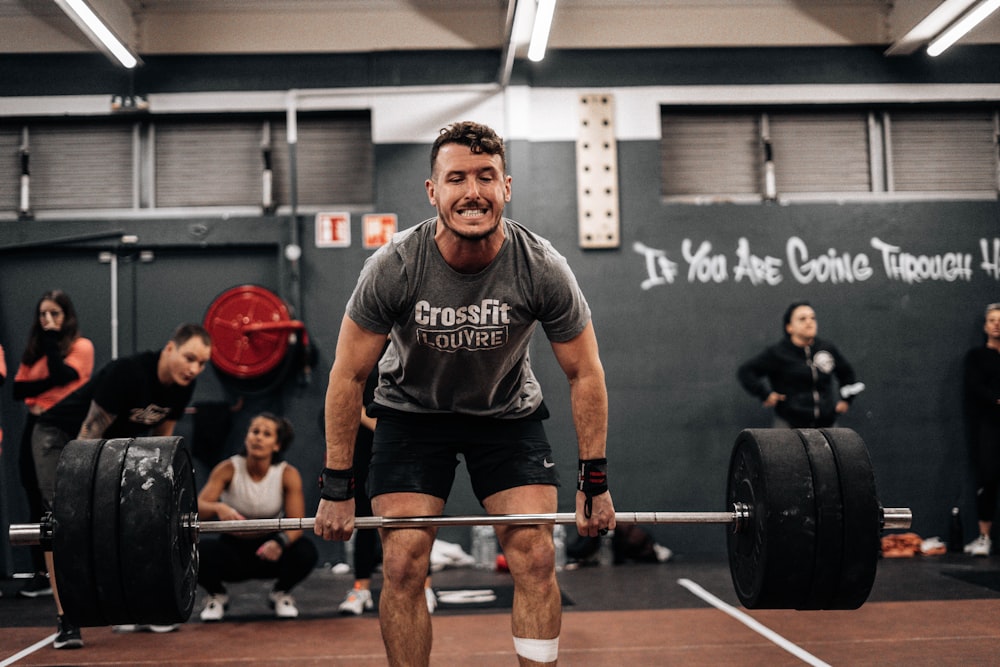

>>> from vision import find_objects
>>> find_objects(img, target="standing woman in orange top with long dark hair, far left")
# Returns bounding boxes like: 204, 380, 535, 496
14, 290, 94, 598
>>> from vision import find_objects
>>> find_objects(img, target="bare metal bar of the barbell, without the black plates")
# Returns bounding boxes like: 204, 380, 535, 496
9, 504, 913, 546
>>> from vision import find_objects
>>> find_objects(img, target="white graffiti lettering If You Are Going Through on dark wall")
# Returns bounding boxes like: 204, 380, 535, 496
632, 236, 984, 290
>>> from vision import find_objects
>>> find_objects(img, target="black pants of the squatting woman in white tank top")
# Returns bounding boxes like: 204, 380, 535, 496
198, 535, 319, 595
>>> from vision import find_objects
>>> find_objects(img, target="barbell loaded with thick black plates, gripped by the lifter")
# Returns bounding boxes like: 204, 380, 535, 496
9, 428, 912, 627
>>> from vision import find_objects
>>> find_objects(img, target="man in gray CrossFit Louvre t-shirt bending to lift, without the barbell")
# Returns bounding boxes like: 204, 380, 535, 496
315, 122, 615, 665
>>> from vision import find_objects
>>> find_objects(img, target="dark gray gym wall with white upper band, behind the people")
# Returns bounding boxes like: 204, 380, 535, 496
0, 47, 1000, 572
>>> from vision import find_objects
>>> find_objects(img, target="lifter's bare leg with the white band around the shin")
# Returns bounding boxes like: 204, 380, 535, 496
484, 485, 562, 667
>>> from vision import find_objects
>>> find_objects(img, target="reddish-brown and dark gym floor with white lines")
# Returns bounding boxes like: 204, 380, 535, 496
0, 553, 1000, 667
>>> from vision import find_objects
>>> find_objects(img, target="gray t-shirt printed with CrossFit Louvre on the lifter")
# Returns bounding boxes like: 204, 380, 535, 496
347, 218, 590, 419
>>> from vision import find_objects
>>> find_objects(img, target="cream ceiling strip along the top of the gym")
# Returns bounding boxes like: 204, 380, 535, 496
0, 0, 1000, 56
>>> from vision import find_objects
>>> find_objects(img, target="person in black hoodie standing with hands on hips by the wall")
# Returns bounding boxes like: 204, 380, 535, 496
737, 301, 864, 428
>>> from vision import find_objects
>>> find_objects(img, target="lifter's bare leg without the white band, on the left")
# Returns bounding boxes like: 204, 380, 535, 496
372, 493, 444, 667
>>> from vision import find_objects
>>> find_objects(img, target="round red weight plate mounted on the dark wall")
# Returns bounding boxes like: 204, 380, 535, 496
205, 285, 295, 379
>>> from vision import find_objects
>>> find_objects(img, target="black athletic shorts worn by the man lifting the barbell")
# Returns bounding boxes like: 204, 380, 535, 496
368, 406, 559, 504
